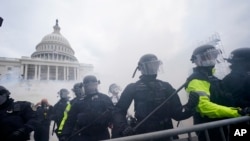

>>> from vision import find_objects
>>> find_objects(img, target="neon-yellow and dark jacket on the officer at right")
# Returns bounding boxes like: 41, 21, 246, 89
186, 68, 240, 119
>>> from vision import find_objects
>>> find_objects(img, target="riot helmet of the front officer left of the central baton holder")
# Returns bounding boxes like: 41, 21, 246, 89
83, 75, 100, 94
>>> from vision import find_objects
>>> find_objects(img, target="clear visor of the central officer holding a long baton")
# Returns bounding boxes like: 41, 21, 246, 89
140, 60, 162, 75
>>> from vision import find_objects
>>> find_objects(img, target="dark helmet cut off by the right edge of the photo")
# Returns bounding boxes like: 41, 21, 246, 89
226, 47, 250, 71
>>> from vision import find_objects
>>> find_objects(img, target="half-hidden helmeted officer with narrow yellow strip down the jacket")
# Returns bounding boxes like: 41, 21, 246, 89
58, 83, 85, 140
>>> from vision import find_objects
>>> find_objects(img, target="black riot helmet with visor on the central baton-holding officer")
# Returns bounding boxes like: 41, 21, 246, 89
132, 54, 162, 77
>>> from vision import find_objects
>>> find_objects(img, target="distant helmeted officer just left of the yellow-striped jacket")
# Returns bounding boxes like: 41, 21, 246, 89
52, 88, 70, 138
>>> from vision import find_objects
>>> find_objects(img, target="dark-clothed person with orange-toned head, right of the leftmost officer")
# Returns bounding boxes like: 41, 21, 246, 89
34, 99, 53, 141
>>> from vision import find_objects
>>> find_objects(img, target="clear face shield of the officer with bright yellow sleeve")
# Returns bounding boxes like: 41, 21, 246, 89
194, 49, 221, 67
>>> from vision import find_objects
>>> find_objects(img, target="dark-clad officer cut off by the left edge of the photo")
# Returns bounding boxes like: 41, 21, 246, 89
0, 86, 37, 141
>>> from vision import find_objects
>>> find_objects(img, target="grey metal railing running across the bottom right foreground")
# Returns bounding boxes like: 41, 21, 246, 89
105, 116, 250, 141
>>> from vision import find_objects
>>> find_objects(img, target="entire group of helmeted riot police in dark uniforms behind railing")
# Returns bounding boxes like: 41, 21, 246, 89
0, 45, 250, 141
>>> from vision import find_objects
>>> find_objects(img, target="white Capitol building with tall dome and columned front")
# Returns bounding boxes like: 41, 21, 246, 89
0, 20, 94, 83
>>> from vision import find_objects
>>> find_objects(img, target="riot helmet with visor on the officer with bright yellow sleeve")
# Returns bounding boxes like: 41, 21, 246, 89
191, 44, 221, 67
